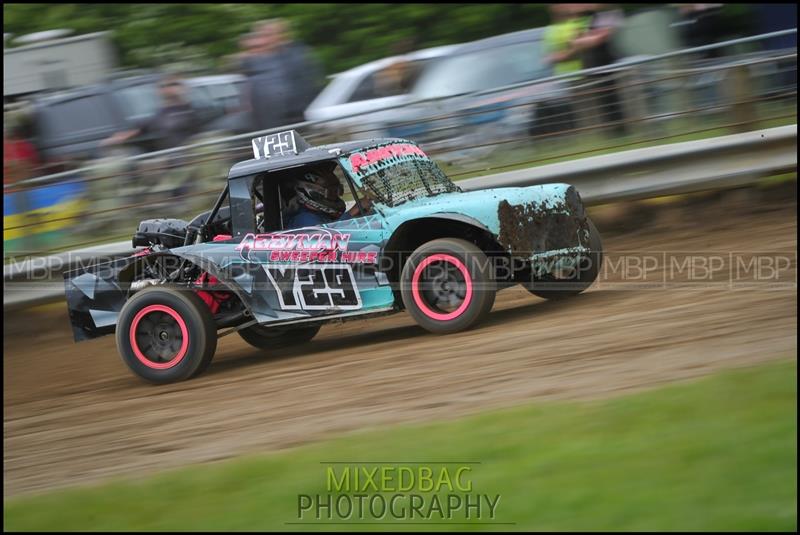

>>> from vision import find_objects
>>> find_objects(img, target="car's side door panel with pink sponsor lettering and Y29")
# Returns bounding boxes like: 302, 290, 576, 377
223, 169, 394, 324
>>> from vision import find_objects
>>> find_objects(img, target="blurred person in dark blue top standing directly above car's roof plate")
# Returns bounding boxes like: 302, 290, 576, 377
240, 19, 321, 130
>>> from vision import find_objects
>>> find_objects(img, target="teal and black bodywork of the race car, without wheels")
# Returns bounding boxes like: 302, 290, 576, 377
65, 132, 591, 340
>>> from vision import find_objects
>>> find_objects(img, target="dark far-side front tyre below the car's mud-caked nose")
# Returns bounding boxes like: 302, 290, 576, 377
525, 219, 603, 300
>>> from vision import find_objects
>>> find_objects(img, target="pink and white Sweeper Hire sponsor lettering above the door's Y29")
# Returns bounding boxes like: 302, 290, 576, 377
236, 228, 378, 264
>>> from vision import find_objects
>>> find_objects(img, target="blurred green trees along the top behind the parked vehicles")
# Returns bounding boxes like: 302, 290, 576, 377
3, 3, 748, 74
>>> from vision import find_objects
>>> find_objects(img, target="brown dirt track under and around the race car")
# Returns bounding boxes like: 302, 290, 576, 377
3, 193, 797, 495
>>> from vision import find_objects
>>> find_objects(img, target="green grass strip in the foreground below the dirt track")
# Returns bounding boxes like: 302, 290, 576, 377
4, 360, 797, 531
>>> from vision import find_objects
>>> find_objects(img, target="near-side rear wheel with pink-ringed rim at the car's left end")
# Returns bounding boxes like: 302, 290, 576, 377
116, 287, 217, 383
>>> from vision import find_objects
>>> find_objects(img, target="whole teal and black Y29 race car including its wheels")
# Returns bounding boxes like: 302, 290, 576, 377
64, 131, 603, 383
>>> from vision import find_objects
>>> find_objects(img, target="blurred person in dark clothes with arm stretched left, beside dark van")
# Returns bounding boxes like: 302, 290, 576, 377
103, 74, 199, 150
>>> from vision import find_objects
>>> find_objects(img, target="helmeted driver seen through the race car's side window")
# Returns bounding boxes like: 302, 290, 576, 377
287, 165, 370, 228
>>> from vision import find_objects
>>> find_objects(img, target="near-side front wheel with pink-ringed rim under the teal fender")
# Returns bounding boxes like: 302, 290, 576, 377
400, 238, 496, 333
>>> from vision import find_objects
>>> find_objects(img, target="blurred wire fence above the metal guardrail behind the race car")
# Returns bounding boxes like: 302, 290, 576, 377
3, 33, 797, 258
